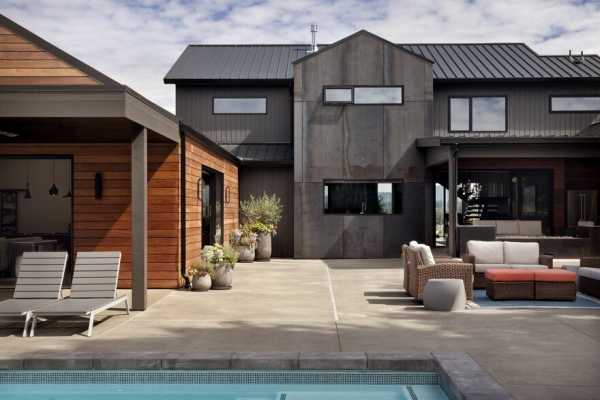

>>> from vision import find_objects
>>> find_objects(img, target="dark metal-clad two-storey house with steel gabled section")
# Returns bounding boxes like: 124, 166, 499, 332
164, 30, 600, 258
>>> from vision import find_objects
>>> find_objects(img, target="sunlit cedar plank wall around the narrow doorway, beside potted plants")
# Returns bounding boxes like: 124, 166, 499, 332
185, 135, 239, 265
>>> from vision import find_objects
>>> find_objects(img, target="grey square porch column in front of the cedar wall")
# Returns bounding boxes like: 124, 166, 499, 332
131, 128, 148, 311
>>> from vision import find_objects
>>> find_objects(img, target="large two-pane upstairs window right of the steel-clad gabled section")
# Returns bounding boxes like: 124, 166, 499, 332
448, 96, 507, 132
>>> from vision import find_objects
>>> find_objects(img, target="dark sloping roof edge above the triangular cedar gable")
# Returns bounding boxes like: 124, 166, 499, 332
0, 14, 121, 86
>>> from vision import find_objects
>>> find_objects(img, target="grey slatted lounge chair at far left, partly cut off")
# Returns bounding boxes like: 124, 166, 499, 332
0, 251, 68, 337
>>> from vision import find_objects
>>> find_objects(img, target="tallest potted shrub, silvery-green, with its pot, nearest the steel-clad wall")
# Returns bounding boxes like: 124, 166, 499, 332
240, 193, 283, 261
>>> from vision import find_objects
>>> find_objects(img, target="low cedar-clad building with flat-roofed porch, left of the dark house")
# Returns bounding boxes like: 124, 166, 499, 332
0, 16, 240, 309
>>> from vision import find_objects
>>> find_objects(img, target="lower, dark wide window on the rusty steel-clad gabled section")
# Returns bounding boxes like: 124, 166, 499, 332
323, 182, 402, 215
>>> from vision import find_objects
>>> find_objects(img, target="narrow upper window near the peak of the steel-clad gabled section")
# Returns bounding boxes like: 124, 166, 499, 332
323, 86, 403, 104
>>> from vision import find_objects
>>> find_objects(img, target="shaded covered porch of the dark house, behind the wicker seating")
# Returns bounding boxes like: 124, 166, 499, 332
417, 136, 600, 257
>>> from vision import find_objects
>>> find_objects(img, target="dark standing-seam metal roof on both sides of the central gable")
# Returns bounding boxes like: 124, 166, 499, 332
164, 38, 600, 83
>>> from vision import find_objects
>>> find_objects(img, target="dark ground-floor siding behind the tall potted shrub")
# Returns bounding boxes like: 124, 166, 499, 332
240, 166, 294, 257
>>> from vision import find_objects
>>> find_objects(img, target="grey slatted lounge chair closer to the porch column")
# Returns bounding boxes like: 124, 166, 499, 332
30, 251, 129, 336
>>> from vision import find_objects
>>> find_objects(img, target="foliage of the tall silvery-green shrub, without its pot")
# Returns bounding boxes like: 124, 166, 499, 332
240, 193, 283, 235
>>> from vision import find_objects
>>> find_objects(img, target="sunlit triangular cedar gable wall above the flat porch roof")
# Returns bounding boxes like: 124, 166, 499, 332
0, 26, 99, 85
